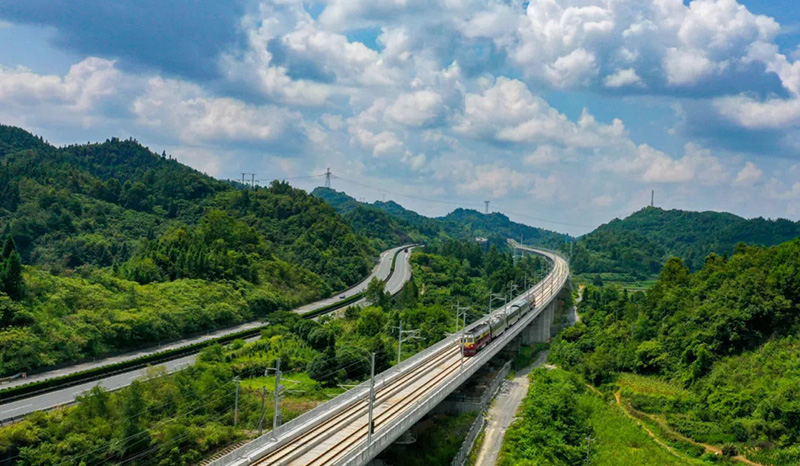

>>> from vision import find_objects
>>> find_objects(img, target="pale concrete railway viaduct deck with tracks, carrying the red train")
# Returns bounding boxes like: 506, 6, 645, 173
212, 248, 569, 466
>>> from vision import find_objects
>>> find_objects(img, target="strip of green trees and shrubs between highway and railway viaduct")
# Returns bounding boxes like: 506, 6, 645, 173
0, 241, 544, 465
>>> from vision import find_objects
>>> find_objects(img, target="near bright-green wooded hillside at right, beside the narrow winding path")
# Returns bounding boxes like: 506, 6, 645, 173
550, 239, 800, 465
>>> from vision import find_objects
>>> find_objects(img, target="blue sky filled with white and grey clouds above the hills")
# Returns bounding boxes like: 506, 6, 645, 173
0, 0, 800, 234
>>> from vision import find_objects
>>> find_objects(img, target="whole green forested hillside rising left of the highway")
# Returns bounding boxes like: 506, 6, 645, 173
0, 126, 378, 375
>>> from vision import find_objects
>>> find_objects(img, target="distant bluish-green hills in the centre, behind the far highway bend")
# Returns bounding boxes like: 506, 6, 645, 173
312, 188, 571, 247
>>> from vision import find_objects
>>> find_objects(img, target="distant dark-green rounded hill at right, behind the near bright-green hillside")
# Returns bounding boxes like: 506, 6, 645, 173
572, 207, 800, 276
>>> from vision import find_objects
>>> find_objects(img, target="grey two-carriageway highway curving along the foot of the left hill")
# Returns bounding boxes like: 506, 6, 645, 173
0, 245, 411, 424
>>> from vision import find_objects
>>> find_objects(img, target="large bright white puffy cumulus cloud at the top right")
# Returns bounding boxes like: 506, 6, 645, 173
509, 0, 780, 92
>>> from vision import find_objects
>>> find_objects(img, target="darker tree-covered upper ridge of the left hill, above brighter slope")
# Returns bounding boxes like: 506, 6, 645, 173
0, 126, 375, 287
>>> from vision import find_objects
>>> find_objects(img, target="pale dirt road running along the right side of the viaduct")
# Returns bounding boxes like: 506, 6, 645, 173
475, 351, 547, 466
